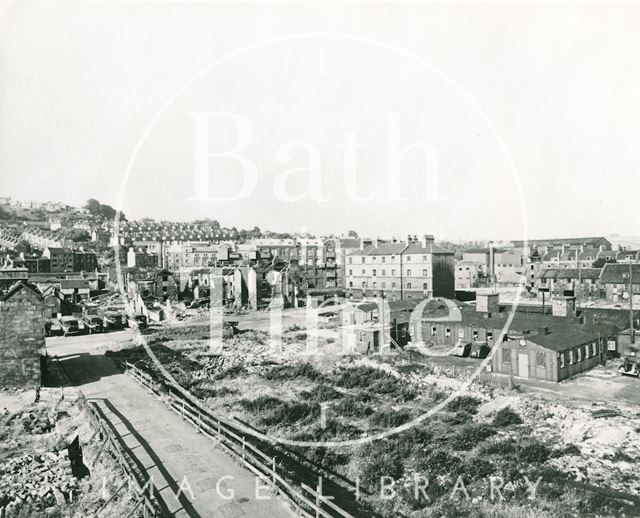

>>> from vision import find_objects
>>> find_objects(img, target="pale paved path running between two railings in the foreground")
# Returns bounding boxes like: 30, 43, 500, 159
47, 334, 295, 518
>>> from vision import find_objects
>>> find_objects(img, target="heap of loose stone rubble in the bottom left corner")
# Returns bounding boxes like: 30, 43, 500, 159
0, 451, 78, 518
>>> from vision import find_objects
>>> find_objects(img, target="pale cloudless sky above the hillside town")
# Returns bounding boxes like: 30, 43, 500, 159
0, 1, 640, 240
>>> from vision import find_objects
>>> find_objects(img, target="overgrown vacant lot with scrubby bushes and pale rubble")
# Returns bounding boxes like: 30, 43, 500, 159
114, 326, 640, 517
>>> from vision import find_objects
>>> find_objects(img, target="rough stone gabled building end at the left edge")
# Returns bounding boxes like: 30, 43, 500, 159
0, 288, 45, 387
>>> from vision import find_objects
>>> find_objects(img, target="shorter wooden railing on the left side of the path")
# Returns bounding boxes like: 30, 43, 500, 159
78, 391, 164, 518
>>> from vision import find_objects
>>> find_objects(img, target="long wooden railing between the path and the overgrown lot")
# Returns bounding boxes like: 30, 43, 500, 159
123, 361, 354, 518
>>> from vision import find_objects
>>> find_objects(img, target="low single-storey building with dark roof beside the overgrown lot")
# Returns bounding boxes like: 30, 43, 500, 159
410, 294, 628, 381
